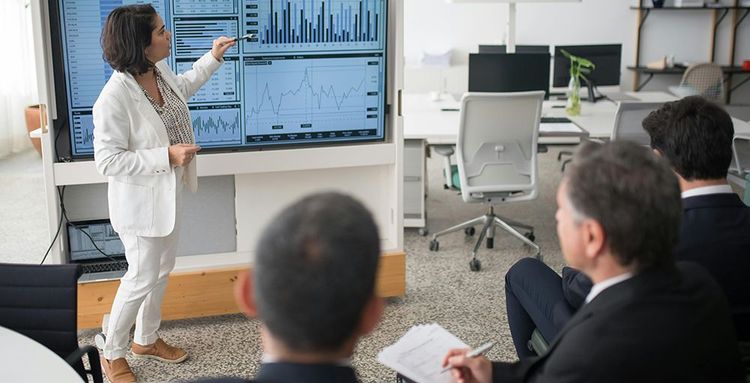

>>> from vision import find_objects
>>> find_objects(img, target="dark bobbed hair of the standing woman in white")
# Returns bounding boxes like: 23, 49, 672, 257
101, 4, 156, 75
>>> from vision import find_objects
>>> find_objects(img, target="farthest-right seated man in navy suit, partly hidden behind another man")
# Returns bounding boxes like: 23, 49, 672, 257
505, 97, 750, 359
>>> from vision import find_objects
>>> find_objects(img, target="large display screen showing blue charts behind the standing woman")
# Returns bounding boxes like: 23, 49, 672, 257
51, 0, 387, 158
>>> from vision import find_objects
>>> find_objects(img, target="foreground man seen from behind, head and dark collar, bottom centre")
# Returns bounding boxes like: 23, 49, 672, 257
191, 193, 383, 383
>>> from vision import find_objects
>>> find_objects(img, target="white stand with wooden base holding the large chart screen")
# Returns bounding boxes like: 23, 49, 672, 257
30, 0, 406, 328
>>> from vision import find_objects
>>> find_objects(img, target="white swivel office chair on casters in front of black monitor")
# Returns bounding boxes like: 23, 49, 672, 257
430, 91, 544, 271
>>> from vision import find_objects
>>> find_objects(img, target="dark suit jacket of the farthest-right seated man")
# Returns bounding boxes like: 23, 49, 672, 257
675, 194, 750, 341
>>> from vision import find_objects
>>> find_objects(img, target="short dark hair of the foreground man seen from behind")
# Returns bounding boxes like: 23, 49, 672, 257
253, 192, 380, 352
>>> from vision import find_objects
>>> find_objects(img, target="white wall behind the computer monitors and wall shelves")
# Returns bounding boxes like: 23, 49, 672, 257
404, 0, 750, 104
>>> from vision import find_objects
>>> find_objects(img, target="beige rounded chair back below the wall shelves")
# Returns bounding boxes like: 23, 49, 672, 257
669, 63, 724, 102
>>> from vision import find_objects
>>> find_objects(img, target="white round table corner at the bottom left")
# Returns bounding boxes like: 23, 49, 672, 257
0, 326, 82, 383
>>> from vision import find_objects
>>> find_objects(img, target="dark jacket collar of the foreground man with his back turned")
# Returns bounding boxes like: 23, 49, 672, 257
196, 363, 359, 383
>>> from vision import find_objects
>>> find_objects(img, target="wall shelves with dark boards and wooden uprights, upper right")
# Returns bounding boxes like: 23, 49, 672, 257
627, 0, 750, 104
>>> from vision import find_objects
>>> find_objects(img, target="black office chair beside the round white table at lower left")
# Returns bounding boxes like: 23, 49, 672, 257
0, 263, 102, 383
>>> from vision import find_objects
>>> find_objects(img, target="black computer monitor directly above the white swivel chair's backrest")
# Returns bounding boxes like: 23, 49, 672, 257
469, 53, 550, 98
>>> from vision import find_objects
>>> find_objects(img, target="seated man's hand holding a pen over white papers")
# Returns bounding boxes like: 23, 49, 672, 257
441, 342, 495, 383
